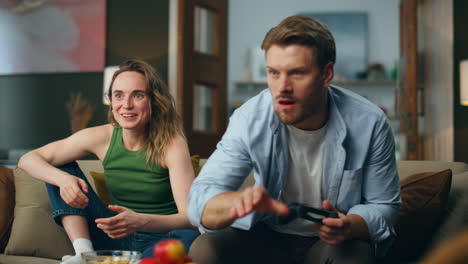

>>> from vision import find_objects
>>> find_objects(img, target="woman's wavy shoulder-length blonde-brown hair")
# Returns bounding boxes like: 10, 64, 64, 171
107, 59, 185, 166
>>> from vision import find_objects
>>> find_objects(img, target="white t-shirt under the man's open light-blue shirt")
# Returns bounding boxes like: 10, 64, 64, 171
270, 122, 327, 236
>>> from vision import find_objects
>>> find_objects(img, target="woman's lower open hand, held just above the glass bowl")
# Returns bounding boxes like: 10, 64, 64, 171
95, 205, 144, 239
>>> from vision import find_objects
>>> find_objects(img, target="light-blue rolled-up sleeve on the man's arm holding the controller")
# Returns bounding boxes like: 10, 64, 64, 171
348, 119, 401, 256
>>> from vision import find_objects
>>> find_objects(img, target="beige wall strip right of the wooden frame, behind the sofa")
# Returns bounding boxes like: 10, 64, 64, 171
418, 0, 452, 161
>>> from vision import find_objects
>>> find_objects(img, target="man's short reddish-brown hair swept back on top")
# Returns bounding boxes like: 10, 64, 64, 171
261, 15, 336, 68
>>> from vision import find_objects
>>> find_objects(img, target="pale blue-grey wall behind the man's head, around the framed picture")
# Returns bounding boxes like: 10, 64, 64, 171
228, 0, 399, 104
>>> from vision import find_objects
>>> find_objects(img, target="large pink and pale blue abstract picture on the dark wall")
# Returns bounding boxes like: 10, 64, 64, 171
0, 0, 106, 74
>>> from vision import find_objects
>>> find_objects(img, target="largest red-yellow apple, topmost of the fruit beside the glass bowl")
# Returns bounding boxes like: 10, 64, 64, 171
153, 239, 185, 264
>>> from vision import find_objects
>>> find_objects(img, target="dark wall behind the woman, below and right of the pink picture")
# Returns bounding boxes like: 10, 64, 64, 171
0, 0, 169, 154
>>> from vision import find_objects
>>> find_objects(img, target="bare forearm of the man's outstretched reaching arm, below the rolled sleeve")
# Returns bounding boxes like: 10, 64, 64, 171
201, 192, 239, 229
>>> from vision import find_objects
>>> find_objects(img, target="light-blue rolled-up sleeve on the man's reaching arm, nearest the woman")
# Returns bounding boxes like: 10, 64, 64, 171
188, 111, 252, 231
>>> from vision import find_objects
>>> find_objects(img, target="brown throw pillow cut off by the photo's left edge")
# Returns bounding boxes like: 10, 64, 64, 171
0, 165, 15, 253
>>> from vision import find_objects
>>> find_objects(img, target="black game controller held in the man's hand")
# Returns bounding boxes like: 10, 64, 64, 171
275, 203, 338, 225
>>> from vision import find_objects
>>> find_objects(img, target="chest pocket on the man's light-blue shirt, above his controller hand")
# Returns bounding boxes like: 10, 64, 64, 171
337, 168, 362, 213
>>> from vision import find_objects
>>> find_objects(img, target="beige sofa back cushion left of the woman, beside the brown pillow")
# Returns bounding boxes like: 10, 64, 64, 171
5, 168, 74, 259
